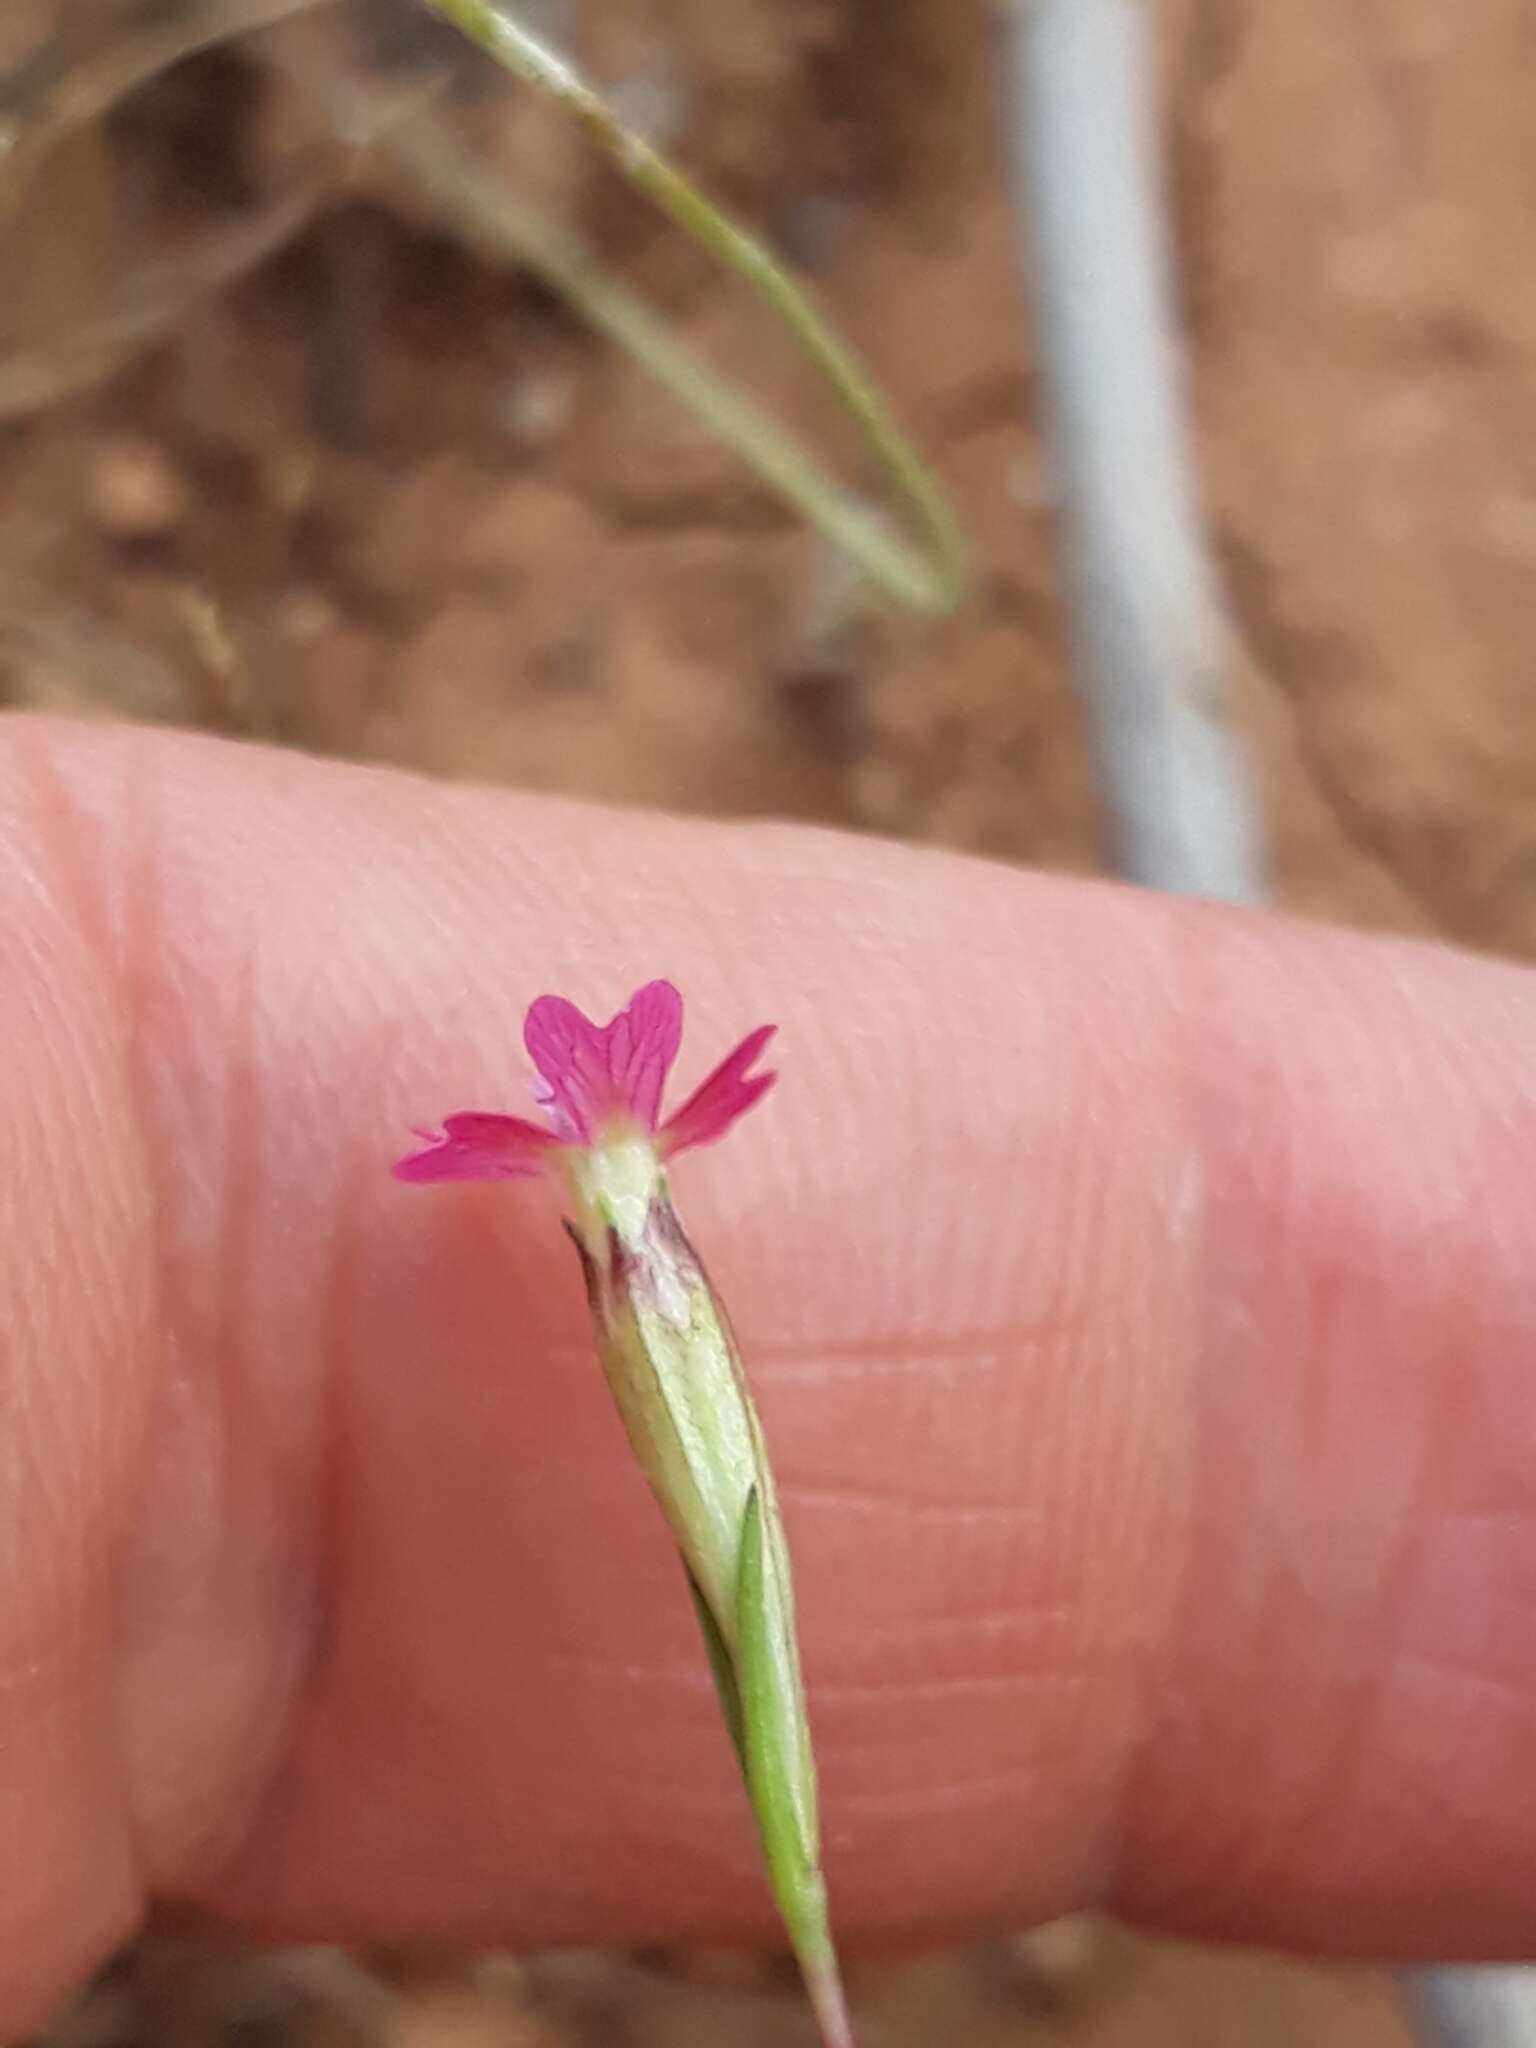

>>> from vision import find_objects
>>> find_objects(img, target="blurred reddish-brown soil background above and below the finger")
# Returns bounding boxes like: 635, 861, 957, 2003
0, 0, 1536, 2048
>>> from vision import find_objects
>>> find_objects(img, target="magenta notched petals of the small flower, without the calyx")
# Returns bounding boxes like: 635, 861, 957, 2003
395, 981, 776, 1180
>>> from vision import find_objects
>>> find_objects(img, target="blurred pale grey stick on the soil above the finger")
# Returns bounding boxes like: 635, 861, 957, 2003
1004, 0, 1264, 903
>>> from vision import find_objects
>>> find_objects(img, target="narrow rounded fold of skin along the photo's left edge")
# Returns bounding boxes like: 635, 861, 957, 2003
0, 733, 150, 2015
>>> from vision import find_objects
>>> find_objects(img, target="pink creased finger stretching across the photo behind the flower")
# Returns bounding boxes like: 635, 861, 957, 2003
0, 719, 1536, 2040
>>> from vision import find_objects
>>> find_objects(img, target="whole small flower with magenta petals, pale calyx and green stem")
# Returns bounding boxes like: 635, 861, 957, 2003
395, 981, 852, 2048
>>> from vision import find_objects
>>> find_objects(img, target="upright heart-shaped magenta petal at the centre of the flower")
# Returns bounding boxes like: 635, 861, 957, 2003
522, 981, 682, 1145
